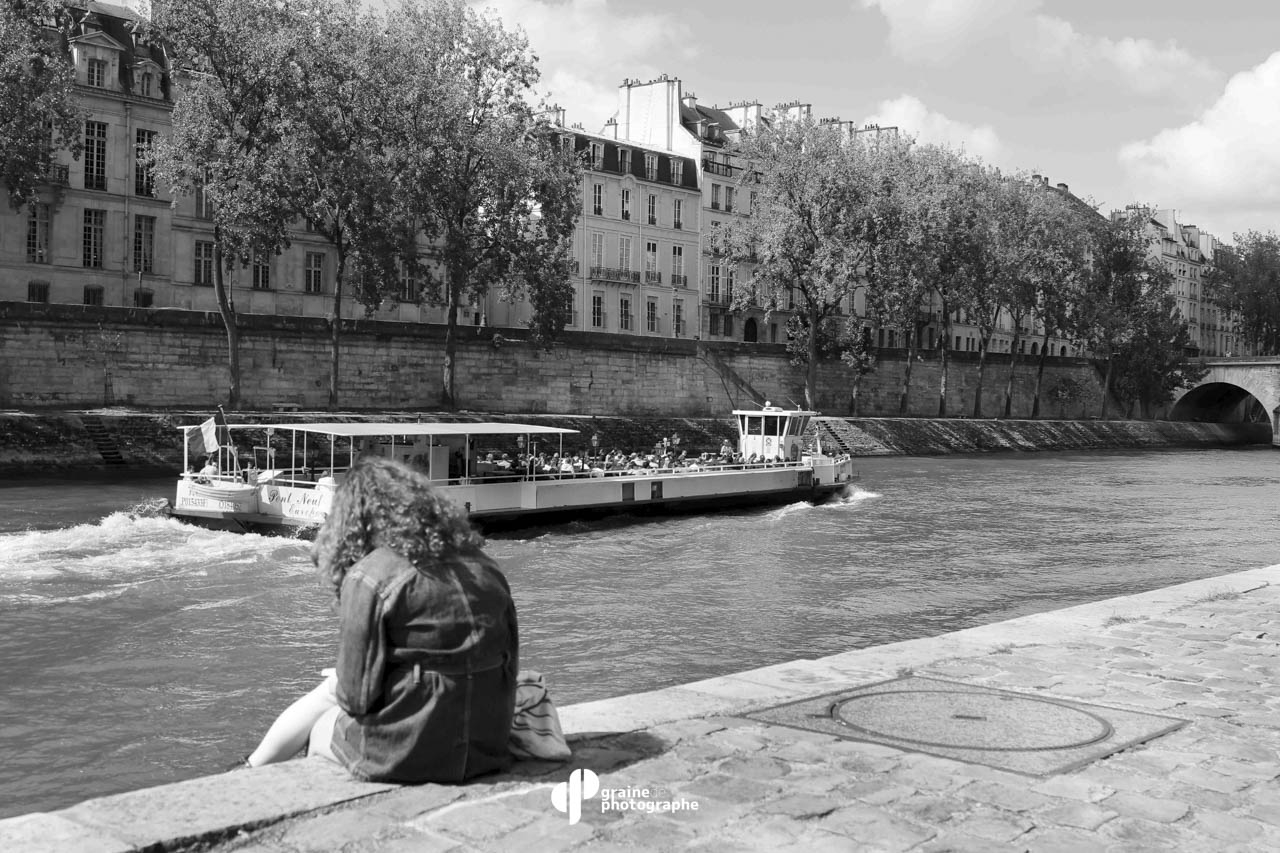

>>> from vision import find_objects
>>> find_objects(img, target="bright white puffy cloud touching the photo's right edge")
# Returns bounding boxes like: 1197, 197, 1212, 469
1119, 53, 1280, 237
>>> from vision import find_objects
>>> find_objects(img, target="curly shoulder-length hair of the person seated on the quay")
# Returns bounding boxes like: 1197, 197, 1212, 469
311, 457, 484, 596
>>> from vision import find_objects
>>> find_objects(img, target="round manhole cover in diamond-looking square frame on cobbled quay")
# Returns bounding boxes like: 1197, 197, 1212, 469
746, 676, 1187, 776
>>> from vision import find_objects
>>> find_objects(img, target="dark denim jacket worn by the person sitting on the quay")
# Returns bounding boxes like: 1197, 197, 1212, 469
333, 548, 520, 783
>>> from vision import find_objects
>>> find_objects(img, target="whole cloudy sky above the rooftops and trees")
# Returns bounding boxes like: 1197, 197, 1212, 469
391, 0, 1280, 242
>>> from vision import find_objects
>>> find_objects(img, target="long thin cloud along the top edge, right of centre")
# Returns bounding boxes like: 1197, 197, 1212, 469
861, 0, 1221, 97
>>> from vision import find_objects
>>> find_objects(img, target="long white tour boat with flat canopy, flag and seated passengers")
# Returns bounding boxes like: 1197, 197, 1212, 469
169, 406, 854, 533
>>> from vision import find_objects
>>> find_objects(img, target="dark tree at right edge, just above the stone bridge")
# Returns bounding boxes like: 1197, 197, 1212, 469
1204, 231, 1280, 353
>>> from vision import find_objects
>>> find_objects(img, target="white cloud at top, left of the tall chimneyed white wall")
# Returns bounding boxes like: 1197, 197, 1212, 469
471, 0, 696, 131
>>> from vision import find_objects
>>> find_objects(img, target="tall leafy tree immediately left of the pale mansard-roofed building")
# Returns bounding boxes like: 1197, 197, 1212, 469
387, 0, 581, 407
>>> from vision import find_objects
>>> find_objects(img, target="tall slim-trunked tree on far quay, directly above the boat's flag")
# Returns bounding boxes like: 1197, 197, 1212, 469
154, 0, 327, 410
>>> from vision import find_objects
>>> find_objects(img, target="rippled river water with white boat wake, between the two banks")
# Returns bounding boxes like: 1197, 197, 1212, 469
0, 448, 1280, 817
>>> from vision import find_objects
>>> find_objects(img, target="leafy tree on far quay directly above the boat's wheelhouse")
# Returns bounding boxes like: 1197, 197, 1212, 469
712, 118, 902, 409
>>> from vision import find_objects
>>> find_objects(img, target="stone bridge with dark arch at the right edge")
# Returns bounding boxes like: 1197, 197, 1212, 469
1169, 356, 1280, 447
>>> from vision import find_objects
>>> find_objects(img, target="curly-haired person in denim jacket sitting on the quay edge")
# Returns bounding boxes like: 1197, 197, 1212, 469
246, 459, 520, 783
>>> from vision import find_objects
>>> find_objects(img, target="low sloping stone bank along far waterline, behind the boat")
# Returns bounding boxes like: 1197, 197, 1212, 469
0, 409, 1271, 473
